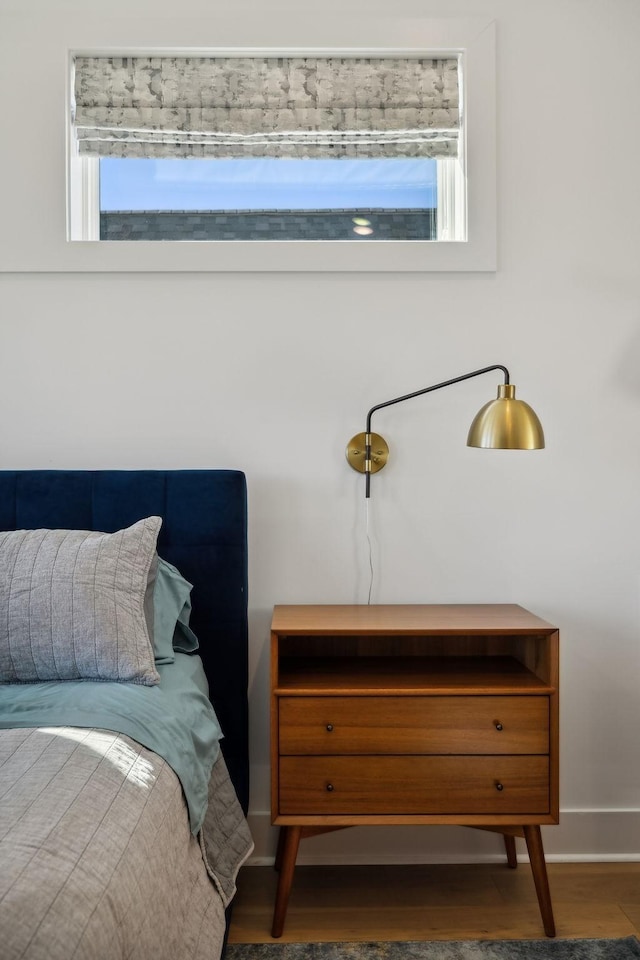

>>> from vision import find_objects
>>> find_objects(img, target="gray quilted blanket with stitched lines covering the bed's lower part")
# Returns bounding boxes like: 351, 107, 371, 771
0, 727, 253, 960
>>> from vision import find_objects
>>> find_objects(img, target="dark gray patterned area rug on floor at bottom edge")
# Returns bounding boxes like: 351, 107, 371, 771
225, 937, 640, 960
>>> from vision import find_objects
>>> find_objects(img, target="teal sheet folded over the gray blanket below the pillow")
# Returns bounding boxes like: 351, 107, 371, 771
0, 653, 222, 834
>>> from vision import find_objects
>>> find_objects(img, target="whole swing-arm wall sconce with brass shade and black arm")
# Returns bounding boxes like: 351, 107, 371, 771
346, 363, 544, 497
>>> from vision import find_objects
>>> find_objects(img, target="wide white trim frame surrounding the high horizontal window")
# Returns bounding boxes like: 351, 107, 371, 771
0, 11, 496, 273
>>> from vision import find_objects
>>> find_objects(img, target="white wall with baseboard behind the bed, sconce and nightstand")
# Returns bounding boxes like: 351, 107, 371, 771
0, 0, 640, 861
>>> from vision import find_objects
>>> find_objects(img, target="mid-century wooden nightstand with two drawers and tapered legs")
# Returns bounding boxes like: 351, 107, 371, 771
271, 604, 559, 937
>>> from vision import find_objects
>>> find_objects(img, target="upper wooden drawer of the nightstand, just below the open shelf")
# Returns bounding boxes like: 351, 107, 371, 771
279, 696, 549, 755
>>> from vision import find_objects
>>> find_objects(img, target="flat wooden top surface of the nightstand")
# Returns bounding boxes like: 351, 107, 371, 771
271, 603, 557, 635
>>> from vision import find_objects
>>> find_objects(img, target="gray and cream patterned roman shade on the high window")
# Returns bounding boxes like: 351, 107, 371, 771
72, 56, 460, 158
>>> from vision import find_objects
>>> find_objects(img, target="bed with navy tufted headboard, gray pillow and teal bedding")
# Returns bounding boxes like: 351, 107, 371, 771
0, 470, 253, 960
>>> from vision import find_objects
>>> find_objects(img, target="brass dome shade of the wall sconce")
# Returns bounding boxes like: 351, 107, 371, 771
467, 383, 544, 450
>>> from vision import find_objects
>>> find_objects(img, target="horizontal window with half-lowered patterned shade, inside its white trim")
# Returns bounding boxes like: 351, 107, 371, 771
73, 56, 466, 243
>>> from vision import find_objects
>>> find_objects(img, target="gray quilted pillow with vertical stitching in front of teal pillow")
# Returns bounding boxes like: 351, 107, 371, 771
0, 517, 162, 684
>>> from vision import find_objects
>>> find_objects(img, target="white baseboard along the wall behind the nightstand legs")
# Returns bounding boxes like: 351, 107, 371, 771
247, 810, 640, 866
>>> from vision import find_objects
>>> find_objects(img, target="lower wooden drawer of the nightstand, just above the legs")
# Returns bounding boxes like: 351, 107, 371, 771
279, 756, 549, 816
